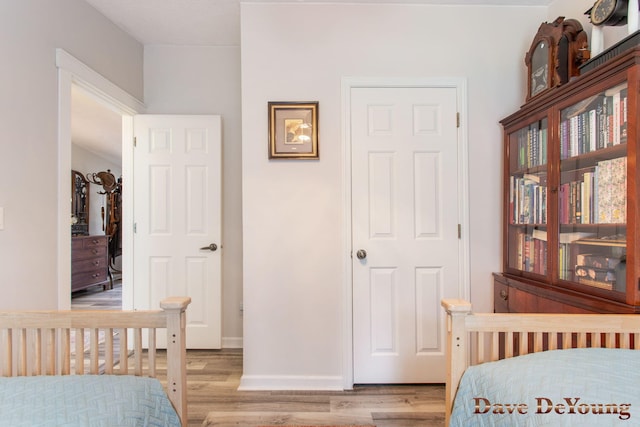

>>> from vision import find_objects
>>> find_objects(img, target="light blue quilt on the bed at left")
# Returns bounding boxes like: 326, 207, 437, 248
0, 375, 180, 427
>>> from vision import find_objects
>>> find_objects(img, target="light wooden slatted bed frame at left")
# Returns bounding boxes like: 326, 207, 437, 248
0, 297, 191, 425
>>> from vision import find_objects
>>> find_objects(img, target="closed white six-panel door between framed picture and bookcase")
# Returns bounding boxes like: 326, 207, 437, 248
350, 87, 460, 384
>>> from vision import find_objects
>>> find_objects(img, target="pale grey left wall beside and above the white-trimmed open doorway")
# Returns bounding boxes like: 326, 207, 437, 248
0, 0, 142, 309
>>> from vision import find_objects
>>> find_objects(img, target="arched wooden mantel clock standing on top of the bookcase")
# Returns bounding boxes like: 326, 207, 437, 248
524, 16, 589, 101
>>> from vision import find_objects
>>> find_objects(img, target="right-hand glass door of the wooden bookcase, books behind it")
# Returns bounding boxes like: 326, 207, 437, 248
558, 83, 627, 292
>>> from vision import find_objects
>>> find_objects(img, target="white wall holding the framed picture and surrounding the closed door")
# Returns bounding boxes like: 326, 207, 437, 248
241, 3, 547, 387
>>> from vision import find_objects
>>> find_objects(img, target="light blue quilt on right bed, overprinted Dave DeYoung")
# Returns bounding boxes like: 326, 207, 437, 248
451, 348, 640, 427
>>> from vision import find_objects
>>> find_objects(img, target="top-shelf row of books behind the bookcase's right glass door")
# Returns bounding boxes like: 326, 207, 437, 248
560, 84, 627, 159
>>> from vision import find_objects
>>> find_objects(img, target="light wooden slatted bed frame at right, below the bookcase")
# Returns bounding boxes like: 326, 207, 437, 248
442, 299, 640, 426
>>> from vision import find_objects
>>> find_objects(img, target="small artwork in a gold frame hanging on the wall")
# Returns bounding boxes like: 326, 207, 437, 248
269, 101, 319, 159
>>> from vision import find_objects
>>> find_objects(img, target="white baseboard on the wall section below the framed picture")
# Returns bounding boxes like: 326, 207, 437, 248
238, 375, 344, 391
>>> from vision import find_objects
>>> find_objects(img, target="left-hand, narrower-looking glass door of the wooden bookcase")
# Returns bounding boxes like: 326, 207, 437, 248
506, 118, 548, 275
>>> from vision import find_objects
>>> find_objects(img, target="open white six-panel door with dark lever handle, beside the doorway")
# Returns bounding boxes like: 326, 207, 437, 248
133, 115, 222, 349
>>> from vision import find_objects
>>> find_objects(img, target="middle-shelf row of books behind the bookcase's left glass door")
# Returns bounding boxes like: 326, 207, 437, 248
509, 175, 547, 224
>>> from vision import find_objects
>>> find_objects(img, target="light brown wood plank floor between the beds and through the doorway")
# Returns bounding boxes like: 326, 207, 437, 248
72, 284, 444, 427
